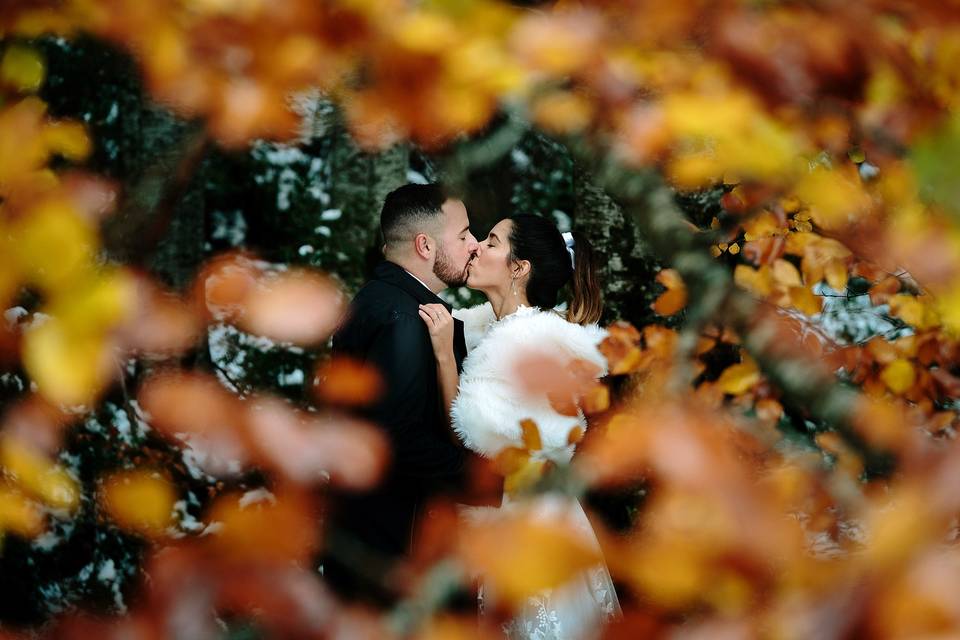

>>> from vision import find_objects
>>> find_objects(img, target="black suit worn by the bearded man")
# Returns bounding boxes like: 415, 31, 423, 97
324, 262, 467, 595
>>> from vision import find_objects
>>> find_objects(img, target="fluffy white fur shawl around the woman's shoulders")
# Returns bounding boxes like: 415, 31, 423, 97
451, 302, 607, 462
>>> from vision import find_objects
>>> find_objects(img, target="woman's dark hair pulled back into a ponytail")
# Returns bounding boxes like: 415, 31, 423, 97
510, 214, 603, 324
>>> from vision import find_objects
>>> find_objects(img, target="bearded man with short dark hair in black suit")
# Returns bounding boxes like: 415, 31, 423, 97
324, 184, 479, 604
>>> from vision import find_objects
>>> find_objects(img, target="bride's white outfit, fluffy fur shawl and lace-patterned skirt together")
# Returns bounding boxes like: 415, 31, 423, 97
451, 303, 621, 640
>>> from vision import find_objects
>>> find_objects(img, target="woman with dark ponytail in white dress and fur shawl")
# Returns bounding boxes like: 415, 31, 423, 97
420, 215, 620, 640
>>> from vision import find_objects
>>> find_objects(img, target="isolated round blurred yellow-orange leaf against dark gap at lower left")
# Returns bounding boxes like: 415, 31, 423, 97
101, 471, 176, 537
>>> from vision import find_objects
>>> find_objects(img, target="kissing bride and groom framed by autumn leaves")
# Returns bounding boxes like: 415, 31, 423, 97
323, 184, 620, 639
